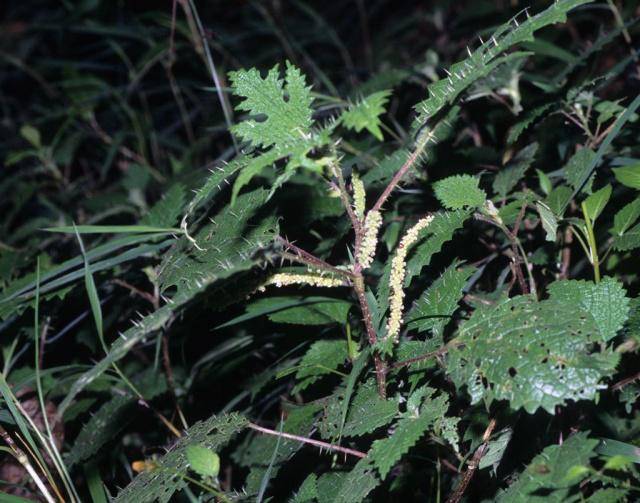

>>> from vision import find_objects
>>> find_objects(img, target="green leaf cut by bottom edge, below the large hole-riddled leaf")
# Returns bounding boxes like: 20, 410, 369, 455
496, 433, 598, 503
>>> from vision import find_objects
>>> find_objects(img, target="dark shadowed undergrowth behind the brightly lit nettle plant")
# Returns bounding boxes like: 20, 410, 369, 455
0, 0, 640, 501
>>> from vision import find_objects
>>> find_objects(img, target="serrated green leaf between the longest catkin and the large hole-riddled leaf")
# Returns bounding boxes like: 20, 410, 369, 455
406, 264, 475, 337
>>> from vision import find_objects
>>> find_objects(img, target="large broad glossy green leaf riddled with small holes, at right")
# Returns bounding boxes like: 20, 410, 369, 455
447, 296, 619, 414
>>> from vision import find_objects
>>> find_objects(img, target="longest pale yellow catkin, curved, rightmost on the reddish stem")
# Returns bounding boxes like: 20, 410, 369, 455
387, 215, 433, 341
